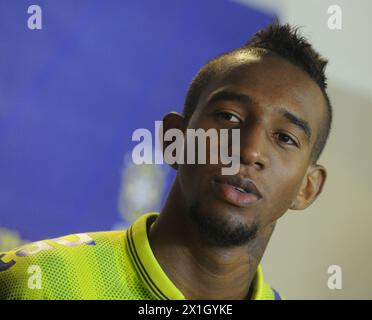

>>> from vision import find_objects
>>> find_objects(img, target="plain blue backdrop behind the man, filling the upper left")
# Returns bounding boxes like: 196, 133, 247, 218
0, 0, 272, 245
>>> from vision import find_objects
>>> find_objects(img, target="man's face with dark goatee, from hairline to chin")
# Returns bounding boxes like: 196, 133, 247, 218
174, 56, 325, 246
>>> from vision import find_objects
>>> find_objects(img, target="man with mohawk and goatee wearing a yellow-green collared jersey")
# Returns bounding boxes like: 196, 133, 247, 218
0, 24, 332, 300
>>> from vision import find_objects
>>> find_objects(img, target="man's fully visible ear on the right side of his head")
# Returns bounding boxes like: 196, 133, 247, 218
289, 164, 327, 210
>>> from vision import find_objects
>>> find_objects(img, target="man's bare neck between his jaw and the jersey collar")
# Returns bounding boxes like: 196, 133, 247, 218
149, 178, 274, 300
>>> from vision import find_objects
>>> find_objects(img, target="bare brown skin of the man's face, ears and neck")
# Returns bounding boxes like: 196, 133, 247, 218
149, 54, 326, 300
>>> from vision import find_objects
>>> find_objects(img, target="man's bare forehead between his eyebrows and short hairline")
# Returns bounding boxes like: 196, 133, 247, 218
196, 55, 326, 140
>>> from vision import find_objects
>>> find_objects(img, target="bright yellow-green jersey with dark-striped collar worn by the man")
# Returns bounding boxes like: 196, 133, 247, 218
0, 212, 280, 300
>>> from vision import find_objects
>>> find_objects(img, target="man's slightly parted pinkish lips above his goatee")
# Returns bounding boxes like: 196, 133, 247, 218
212, 175, 262, 208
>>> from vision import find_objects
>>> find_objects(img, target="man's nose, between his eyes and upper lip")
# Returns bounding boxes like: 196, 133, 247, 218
240, 124, 269, 170
